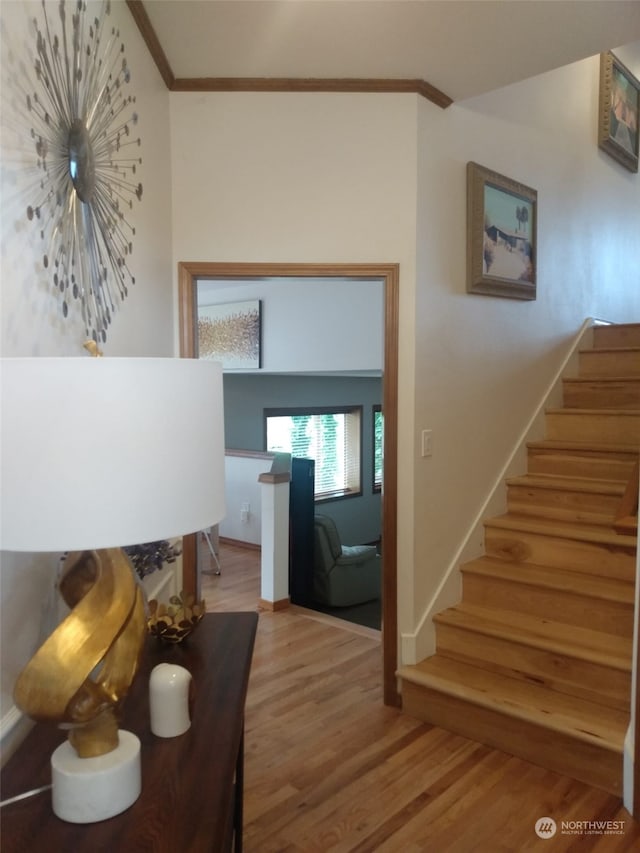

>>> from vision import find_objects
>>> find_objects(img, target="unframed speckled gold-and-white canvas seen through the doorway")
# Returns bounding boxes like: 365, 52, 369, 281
198, 299, 262, 370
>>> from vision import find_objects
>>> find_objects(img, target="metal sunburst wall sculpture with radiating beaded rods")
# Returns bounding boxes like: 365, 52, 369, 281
27, 0, 142, 342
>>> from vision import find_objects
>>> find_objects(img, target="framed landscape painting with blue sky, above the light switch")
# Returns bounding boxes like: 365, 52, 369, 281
467, 163, 538, 299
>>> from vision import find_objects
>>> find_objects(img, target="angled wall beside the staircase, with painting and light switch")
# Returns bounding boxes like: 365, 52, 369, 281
410, 51, 640, 648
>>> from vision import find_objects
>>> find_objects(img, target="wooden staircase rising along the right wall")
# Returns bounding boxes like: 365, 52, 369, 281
398, 324, 640, 795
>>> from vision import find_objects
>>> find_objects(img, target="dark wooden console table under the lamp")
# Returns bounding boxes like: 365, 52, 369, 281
0, 613, 258, 853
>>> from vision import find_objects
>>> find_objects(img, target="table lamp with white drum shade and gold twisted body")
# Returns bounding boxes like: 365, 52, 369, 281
0, 357, 225, 823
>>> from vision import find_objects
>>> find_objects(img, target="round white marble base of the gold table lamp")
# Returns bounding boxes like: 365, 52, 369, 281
51, 731, 142, 823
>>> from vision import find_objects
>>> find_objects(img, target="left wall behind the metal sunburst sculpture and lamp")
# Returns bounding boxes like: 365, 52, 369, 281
0, 0, 174, 752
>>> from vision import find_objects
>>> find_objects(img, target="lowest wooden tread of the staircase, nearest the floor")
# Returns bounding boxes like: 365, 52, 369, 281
397, 655, 629, 753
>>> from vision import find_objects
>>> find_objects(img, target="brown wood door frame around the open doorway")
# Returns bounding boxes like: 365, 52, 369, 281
178, 261, 400, 707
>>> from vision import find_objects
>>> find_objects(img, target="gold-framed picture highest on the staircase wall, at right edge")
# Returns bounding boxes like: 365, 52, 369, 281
598, 52, 640, 172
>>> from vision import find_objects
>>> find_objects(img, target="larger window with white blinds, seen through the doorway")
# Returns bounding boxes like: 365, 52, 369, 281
264, 406, 362, 500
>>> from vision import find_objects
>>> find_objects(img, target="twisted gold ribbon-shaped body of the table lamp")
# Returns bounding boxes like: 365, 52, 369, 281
14, 548, 146, 758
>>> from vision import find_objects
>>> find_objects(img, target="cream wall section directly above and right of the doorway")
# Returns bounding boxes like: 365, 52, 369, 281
171, 92, 418, 624
